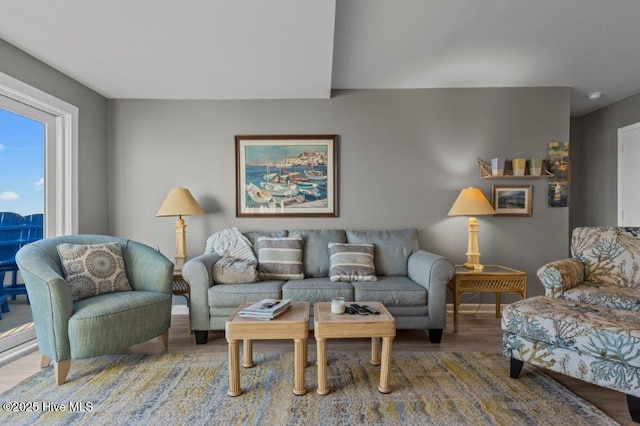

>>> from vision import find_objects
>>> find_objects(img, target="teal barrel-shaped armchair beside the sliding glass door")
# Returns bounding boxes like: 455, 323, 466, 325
16, 235, 173, 385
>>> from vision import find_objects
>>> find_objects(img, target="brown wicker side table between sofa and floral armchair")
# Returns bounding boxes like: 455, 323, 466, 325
447, 265, 527, 333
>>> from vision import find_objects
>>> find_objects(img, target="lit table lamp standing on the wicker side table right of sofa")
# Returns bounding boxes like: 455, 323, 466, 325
447, 187, 496, 270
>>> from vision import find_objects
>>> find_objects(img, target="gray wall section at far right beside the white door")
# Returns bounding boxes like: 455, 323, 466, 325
571, 94, 640, 229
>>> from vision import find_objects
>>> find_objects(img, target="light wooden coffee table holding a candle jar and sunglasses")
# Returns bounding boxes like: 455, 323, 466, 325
313, 302, 396, 395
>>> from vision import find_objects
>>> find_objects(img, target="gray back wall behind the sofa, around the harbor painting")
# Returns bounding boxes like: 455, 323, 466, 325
109, 88, 569, 303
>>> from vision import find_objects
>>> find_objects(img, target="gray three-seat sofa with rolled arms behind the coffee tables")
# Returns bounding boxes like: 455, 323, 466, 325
182, 228, 455, 344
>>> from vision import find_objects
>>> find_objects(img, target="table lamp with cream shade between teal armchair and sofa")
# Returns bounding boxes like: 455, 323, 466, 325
156, 188, 204, 270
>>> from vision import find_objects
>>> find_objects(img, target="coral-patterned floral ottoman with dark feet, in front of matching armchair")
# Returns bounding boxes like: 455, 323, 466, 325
502, 296, 640, 396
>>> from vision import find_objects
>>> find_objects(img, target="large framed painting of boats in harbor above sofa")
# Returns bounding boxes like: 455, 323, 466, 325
235, 135, 338, 217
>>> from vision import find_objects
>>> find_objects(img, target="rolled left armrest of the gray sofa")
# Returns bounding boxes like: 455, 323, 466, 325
182, 253, 220, 331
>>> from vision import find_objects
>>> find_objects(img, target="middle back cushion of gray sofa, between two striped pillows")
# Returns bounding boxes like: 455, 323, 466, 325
289, 229, 347, 278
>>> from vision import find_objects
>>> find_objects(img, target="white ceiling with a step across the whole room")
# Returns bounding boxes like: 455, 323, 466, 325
0, 0, 640, 115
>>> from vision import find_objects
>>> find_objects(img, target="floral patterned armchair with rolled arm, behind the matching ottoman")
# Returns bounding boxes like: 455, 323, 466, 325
538, 227, 640, 312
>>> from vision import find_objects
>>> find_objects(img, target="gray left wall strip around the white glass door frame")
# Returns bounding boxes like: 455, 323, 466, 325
0, 39, 109, 234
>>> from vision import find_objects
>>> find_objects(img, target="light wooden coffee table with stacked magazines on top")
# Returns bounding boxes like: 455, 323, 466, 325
225, 302, 309, 396
